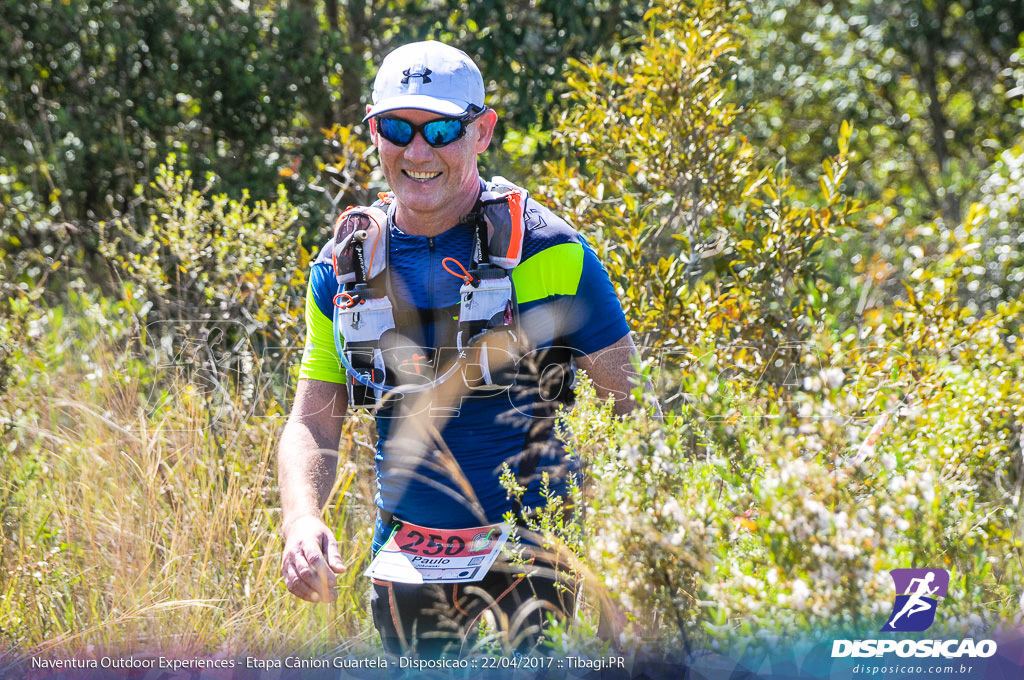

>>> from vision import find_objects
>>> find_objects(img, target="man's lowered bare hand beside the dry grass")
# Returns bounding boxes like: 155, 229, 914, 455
281, 516, 345, 602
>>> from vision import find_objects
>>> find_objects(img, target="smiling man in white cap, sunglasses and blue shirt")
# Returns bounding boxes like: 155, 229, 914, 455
279, 41, 637, 655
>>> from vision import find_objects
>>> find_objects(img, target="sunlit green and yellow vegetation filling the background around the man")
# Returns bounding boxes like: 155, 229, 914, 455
0, 0, 1024, 669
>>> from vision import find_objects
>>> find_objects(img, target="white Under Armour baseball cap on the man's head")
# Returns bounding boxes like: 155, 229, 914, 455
362, 40, 483, 120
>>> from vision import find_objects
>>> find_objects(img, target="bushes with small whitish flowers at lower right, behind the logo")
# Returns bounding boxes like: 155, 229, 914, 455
567, 284, 1024, 650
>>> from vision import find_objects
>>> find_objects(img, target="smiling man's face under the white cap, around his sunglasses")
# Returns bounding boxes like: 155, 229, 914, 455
370, 109, 497, 228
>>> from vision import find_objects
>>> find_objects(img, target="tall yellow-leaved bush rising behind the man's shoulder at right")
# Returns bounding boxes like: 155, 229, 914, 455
544, 2, 856, 393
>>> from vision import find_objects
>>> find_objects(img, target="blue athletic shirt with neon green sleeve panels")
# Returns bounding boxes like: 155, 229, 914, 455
299, 182, 629, 547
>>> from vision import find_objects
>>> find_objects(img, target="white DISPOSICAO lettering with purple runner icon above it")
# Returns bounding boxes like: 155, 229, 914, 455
831, 569, 996, 658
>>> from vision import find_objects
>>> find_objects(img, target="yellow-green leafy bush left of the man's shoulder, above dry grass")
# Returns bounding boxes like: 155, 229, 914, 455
99, 155, 309, 419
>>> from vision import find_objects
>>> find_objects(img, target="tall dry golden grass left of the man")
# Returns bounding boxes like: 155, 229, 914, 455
0, 292, 376, 667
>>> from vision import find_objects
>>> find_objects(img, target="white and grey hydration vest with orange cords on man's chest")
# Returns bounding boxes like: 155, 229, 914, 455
332, 177, 528, 408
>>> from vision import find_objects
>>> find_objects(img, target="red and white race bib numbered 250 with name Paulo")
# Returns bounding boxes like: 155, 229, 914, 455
366, 522, 511, 583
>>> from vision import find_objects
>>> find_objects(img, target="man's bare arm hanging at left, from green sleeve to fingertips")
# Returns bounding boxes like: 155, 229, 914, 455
278, 379, 347, 602
